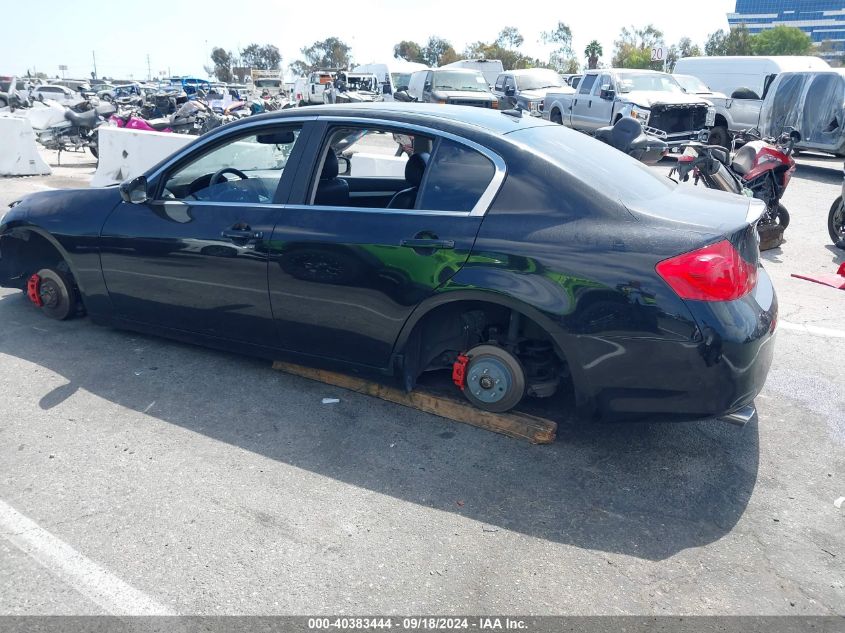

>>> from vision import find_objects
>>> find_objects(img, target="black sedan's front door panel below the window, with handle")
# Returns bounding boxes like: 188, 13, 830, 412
100, 202, 279, 345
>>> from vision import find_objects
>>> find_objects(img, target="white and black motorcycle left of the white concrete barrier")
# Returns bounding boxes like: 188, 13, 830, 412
28, 101, 116, 161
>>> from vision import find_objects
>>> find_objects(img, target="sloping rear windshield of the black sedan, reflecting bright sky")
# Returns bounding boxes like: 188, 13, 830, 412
508, 125, 676, 205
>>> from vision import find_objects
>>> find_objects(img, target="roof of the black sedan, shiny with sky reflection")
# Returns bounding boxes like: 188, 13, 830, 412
249, 101, 557, 134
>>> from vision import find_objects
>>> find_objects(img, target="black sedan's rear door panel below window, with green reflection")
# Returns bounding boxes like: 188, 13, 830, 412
268, 205, 481, 367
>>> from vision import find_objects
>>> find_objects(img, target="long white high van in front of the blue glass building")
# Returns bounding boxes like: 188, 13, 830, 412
672, 55, 830, 99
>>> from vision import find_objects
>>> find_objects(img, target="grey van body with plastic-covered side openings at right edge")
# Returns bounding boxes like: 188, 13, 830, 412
759, 68, 845, 156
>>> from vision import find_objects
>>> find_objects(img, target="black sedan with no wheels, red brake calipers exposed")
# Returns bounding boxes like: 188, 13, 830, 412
0, 104, 777, 421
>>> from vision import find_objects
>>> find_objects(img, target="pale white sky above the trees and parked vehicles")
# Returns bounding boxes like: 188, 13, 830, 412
0, 0, 735, 79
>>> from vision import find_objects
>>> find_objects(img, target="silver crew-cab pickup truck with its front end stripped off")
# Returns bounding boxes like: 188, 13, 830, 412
543, 68, 716, 147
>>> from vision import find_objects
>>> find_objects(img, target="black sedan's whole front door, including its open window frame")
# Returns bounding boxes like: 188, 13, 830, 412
100, 122, 309, 345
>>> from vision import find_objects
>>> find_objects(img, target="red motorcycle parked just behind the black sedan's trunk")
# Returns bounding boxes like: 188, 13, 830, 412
670, 128, 801, 229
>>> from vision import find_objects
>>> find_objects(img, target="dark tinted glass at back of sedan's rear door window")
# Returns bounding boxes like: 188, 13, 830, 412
417, 138, 496, 213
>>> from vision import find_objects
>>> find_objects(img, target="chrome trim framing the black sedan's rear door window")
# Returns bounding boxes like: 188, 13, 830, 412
314, 115, 507, 217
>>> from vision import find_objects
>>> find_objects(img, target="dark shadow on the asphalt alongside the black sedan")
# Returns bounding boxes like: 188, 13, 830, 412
0, 293, 759, 560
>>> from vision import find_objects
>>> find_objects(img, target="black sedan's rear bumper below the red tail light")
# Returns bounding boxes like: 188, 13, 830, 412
576, 268, 778, 419
